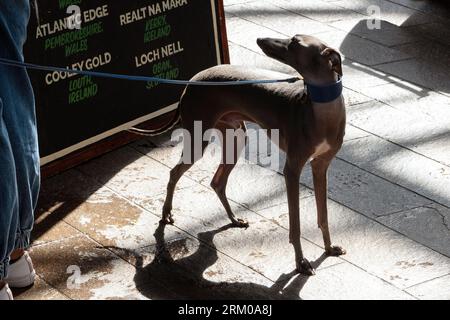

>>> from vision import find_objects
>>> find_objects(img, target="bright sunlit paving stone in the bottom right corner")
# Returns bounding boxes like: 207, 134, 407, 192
406, 275, 450, 300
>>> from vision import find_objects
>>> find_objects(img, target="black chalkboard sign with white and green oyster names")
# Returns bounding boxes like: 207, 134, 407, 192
25, 0, 223, 168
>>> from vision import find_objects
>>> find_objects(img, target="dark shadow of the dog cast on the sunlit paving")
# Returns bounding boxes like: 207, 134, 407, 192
115, 223, 326, 300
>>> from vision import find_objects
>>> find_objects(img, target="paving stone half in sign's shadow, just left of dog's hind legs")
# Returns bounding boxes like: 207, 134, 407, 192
78, 148, 194, 201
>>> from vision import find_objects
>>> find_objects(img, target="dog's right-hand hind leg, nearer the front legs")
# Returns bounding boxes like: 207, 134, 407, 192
211, 122, 248, 228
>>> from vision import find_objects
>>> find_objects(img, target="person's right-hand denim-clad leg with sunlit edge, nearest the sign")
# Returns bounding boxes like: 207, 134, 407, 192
0, 0, 40, 272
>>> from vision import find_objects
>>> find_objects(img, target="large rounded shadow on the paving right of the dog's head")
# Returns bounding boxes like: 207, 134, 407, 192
339, 17, 450, 99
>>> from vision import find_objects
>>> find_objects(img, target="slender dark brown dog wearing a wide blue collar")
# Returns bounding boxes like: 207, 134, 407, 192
163, 35, 345, 275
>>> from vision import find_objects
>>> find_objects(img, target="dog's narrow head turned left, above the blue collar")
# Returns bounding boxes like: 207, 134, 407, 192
256, 34, 342, 81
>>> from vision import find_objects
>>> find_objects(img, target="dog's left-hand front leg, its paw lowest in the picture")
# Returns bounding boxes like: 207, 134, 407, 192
284, 157, 315, 275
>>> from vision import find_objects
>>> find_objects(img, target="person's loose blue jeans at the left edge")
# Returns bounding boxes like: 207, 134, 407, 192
0, 0, 40, 279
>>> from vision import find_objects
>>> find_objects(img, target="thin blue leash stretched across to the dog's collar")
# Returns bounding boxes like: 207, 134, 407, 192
0, 58, 300, 86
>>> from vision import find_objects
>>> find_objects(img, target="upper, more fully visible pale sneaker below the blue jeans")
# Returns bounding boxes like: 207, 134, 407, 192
4, 251, 36, 288
